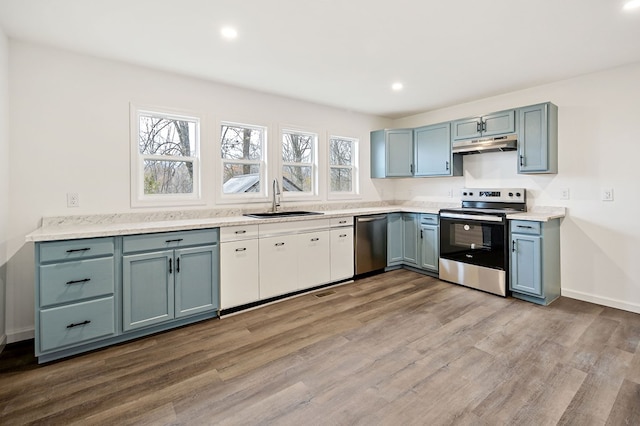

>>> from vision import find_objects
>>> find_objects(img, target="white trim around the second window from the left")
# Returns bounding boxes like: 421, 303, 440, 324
215, 120, 270, 204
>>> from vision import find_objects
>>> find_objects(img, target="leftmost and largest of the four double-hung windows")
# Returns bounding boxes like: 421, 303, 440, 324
131, 106, 200, 206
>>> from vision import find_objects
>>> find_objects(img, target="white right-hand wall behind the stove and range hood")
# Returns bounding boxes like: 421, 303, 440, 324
393, 64, 640, 312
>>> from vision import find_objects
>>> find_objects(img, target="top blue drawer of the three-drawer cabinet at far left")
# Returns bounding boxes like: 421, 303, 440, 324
40, 238, 113, 262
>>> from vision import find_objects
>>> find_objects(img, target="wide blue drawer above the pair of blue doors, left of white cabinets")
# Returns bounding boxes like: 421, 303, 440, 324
122, 228, 219, 253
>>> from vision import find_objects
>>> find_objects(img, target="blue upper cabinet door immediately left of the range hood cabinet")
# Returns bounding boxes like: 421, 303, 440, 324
413, 123, 452, 176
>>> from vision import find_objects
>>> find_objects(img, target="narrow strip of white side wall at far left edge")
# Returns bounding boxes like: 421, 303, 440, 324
0, 27, 9, 351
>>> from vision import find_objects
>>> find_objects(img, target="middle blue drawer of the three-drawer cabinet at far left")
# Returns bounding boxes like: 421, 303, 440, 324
40, 257, 114, 306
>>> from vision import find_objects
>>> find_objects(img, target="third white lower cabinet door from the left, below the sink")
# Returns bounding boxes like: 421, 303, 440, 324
297, 230, 331, 290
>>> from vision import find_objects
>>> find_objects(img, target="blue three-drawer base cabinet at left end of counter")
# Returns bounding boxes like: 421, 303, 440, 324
35, 237, 117, 359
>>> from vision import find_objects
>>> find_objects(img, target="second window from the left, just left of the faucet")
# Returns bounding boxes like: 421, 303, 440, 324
220, 123, 267, 197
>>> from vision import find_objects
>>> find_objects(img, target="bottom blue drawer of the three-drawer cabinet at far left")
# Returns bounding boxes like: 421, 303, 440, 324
40, 296, 115, 352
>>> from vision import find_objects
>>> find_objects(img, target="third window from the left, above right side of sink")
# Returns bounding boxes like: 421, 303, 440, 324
282, 130, 318, 195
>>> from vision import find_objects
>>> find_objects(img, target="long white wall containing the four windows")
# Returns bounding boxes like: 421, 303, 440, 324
7, 41, 393, 341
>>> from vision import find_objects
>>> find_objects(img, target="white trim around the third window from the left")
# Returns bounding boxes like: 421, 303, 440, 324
276, 126, 320, 201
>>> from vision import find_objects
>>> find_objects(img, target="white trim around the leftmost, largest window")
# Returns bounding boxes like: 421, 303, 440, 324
129, 103, 204, 208
